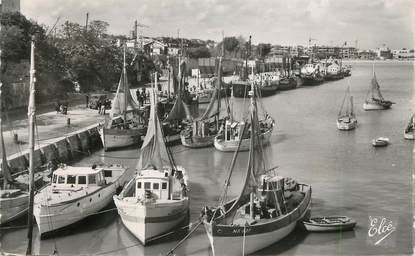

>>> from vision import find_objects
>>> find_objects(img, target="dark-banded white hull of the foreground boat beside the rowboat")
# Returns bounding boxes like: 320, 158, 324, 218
203, 185, 311, 256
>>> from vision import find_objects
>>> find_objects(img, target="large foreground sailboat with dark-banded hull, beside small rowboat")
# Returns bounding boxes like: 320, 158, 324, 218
202, 82, 311, 255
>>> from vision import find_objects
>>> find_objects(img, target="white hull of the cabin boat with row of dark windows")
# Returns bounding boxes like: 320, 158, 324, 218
34, 171, 128, 236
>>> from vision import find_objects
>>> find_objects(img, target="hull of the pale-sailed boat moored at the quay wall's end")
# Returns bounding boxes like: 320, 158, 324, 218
99, 127, 143, 151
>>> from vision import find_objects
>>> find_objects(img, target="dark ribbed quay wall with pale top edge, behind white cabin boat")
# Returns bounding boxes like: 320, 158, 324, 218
0, 124, 102, 176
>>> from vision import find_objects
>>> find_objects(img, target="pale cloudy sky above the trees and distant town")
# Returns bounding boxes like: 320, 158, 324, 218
21, 0, 415, 49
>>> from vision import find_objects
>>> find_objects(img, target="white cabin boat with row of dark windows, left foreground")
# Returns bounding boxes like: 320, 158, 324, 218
34, 165, 132, 235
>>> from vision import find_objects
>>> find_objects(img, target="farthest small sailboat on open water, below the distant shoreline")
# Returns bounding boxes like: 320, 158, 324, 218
363, 65, 395, 110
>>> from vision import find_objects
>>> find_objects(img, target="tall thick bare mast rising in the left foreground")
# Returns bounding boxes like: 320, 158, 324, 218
26, 37, 36, 255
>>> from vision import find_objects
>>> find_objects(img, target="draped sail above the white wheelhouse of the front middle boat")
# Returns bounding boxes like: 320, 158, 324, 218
137, 90, 170, 170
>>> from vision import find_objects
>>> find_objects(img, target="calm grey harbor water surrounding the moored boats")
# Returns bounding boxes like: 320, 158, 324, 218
0, 61, 414, 256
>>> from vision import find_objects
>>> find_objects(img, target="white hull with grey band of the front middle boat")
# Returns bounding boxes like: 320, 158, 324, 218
114, 196, 189, 245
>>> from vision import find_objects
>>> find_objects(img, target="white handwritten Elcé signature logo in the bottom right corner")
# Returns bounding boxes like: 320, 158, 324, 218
367, 216, 398, 247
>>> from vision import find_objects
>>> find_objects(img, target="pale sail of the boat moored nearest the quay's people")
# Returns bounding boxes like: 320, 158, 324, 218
110, 49, 139, 118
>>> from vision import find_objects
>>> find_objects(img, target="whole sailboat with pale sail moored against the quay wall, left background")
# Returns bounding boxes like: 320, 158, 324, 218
99, 46, 146, 151
